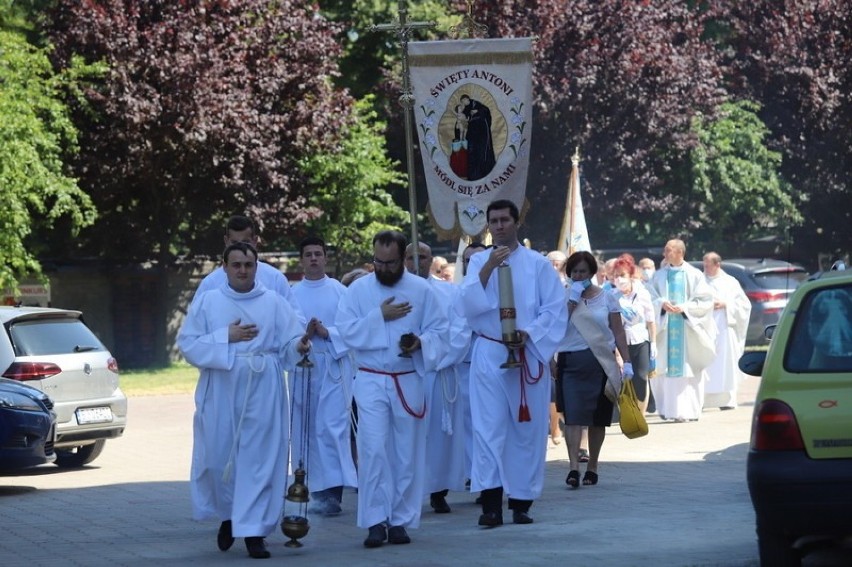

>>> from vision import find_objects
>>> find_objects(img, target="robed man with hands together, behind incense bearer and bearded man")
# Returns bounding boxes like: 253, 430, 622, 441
290, 236, 358, 516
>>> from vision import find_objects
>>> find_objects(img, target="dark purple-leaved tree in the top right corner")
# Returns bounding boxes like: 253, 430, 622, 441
719, 0, 852, 260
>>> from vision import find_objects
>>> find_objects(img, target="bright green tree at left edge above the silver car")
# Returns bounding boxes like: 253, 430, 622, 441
0, 23, 96, 289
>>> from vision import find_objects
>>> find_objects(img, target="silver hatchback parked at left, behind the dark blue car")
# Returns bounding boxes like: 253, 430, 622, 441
0, 307, 127, 467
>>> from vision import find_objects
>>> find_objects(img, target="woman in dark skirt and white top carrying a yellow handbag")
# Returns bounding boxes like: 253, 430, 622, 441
557, 252, 633, 488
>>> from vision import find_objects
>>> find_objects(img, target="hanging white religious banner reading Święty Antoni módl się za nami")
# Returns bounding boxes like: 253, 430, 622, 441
408, 38, 533, 237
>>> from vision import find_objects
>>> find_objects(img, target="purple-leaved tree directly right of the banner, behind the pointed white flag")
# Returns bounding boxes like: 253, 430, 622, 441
462, 0, 725, 241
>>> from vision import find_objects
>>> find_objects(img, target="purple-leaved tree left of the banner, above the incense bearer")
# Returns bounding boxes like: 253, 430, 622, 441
47, 0, 351, 263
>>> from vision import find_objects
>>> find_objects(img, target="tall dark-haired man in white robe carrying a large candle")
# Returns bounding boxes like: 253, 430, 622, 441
455, 200, 568, 528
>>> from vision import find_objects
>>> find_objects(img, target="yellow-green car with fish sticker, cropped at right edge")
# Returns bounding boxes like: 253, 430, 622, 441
740, 270, 852, 567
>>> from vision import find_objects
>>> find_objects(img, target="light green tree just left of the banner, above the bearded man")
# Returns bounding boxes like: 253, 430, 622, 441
299, 97, 407, 274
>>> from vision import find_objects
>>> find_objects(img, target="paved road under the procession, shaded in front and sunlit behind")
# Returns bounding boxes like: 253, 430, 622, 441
0, 378, 832, 567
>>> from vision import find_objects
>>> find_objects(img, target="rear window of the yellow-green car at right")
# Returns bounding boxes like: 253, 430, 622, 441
784, 285, 852, 372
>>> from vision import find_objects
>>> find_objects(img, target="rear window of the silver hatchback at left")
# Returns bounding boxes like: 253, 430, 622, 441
9, 319, 106, 356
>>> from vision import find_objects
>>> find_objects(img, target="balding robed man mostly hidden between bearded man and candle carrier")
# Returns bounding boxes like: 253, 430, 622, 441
405, 242, 470, 514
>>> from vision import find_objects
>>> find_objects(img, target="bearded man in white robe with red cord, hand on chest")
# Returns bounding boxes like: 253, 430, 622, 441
335, 231, 449, 547
